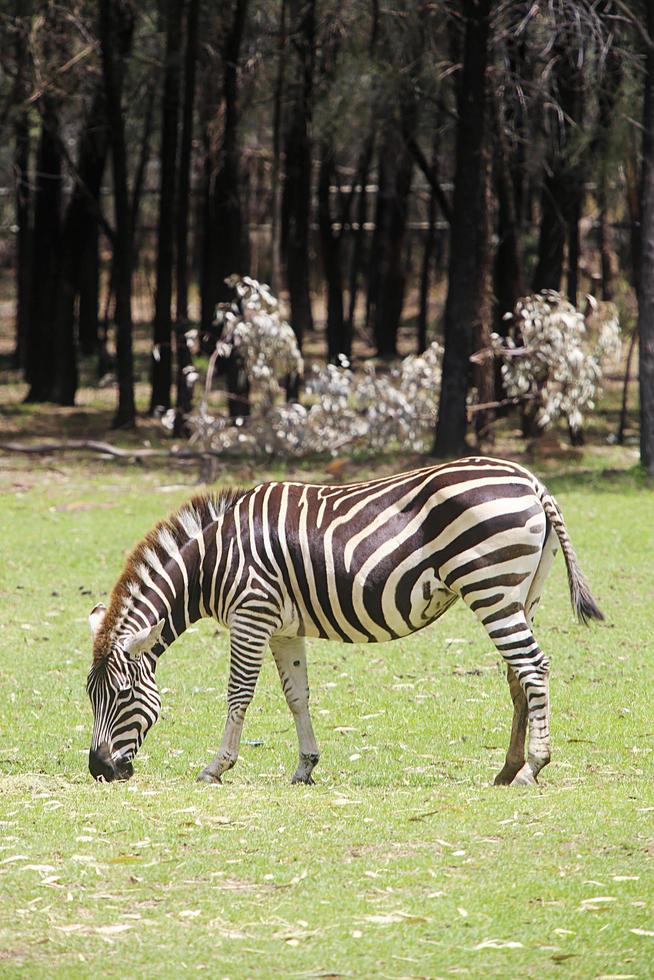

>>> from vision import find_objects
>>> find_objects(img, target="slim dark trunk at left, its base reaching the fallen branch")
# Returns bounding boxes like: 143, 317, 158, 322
100, 0, 136, 428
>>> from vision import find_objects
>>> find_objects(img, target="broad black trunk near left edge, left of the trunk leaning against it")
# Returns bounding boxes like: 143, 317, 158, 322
26, 93, 62, 402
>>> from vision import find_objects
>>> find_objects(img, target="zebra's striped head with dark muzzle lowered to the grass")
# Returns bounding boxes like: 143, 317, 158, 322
86, 604, 164, 782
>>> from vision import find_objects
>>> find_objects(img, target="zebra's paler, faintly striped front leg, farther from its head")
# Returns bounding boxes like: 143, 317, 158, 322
270, 636, 319, 785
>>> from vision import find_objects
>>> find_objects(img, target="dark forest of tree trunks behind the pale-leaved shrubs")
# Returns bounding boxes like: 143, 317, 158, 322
0, 0, 654, 470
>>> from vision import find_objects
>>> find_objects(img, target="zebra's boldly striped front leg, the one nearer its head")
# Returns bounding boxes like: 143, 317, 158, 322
198, 624, 268, 783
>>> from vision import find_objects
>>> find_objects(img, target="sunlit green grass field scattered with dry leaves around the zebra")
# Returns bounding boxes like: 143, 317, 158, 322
0, 458, 654, 978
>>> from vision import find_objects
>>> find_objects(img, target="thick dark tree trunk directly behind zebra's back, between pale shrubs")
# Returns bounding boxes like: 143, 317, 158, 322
433, 0, 491, 457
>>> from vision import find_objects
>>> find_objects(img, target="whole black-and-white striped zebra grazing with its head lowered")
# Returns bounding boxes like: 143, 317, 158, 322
87, 456, 603, 785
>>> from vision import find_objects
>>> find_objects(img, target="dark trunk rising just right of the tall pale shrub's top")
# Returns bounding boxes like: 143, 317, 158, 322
282, 0, 316, 348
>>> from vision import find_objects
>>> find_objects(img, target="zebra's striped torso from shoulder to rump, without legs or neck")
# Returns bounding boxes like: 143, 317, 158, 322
237, 457, 547, 642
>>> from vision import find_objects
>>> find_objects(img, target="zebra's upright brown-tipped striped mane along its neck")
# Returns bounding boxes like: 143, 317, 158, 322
93, 487, 246, 663
